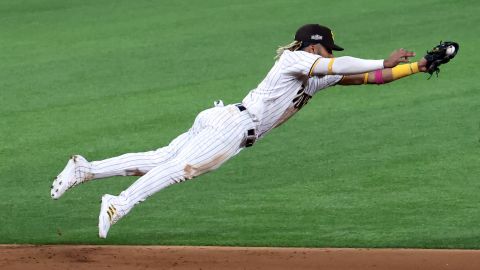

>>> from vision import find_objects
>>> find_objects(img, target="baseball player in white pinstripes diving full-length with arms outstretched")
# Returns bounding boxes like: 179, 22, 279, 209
50, 24, 458, 238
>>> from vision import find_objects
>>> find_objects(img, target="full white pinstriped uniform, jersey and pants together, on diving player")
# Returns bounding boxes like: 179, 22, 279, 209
87, 51, 342, 226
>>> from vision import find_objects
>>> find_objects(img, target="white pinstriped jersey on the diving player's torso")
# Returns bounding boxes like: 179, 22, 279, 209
242, 50, 343, 138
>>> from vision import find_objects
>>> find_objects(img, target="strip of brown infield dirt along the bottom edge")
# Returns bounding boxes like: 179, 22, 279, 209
0, 245, 480, 270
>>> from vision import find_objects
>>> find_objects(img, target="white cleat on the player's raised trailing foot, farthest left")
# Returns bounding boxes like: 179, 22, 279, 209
50, 155, 93, 200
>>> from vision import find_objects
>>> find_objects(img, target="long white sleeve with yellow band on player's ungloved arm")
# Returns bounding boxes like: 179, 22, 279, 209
308, 56, 384, 76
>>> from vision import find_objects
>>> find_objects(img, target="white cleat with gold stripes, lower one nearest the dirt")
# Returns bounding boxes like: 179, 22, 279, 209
98, 194, 125, 238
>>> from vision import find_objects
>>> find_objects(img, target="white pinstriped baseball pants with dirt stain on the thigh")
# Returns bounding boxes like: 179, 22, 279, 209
91, 105, 254, 214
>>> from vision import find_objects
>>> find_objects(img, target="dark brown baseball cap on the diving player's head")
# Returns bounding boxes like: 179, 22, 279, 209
295, 24, 343, 51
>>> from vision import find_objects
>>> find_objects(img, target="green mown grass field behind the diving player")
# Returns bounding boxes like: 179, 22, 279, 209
0, 0, 480, 249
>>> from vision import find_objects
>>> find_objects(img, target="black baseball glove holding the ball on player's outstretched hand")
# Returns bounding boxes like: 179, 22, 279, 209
425, 41, 460, 79
